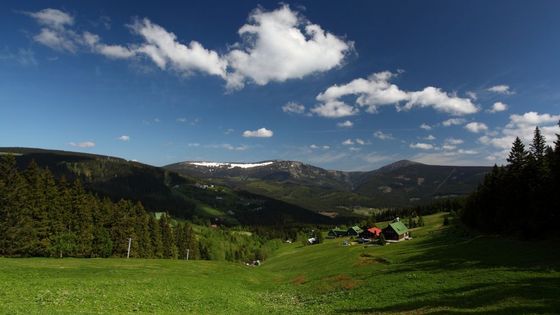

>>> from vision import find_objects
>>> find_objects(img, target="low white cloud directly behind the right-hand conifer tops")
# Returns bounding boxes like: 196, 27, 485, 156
478, 112, 560, 153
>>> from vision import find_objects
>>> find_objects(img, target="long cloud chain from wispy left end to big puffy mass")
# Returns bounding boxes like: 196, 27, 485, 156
25, 5, 353, 90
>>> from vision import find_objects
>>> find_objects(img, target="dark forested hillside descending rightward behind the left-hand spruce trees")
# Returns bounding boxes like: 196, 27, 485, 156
0, 148, 331, 225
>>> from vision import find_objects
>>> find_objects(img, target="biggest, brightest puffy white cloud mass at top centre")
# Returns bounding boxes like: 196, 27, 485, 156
226, 5, 353, 89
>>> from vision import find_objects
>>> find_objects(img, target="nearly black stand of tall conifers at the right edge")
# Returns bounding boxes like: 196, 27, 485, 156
461, 127, 560, 238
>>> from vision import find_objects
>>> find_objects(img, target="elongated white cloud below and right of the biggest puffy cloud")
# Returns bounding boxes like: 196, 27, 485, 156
311, 71, 478, 117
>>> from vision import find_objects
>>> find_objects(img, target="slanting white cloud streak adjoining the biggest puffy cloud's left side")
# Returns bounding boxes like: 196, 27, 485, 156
130, 19, 227, 78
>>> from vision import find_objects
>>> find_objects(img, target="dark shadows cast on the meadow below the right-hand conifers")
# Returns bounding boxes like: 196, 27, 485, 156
339, 230, 560, 315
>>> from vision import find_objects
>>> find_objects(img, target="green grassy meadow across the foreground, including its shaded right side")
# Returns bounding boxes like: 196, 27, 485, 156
0, 214, 560, 314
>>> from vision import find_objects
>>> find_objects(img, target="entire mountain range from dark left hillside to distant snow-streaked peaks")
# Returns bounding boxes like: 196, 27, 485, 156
0, 148, 490, 224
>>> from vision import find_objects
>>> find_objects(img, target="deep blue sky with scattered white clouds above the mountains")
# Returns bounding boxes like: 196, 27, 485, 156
0, 1, 560, 170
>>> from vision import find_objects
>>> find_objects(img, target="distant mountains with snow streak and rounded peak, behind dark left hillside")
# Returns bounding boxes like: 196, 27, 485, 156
165, 160, 490, 213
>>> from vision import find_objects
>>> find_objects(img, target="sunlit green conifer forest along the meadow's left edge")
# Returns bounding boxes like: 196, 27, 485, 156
0, 154, 278, 260
